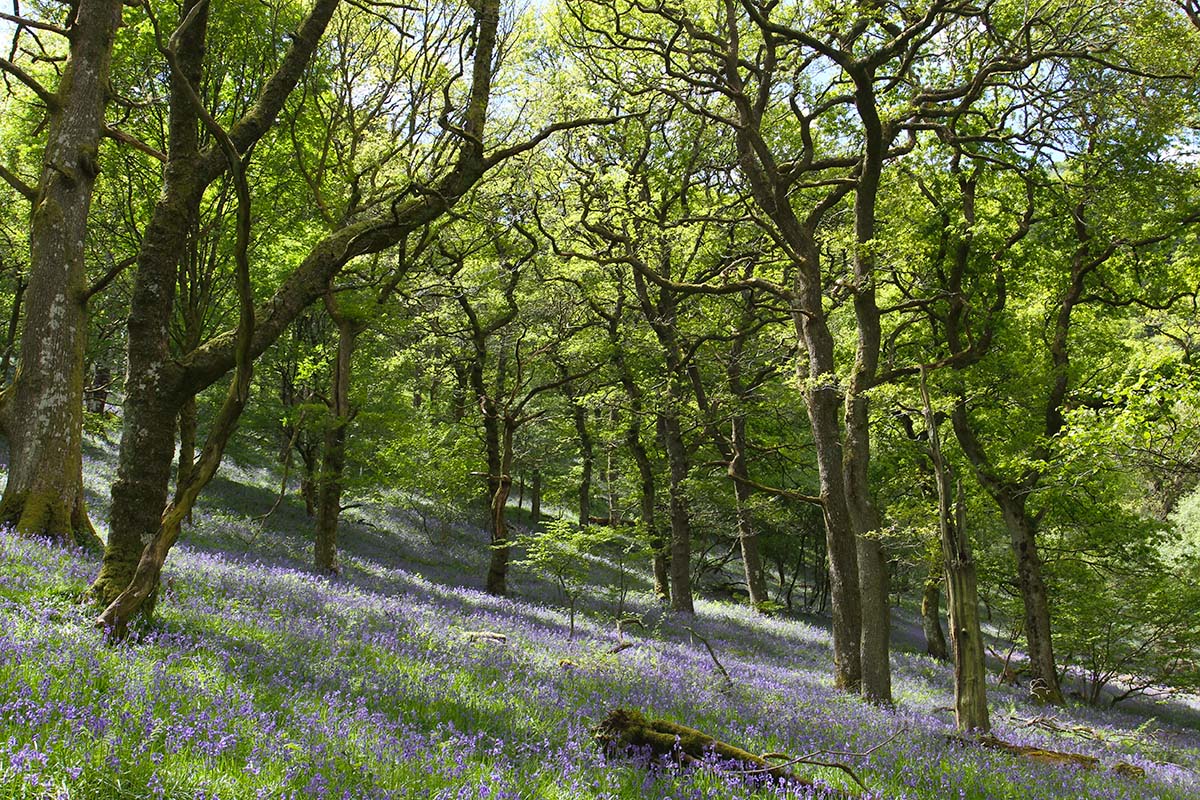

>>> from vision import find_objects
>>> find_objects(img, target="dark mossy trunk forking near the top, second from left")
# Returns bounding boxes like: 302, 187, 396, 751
92, 0, 338, 604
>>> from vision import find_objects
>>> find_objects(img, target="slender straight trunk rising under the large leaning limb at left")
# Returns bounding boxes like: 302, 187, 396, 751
313, 307, 365, 573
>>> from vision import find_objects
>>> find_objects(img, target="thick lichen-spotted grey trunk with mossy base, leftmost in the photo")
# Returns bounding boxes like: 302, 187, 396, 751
0, 0, 121, 547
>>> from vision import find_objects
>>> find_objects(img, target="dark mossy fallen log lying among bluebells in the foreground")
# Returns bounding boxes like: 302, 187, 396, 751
595, 709, 816, 787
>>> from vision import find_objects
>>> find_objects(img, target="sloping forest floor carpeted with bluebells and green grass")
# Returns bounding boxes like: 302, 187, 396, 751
0, 434, 1200, 800
